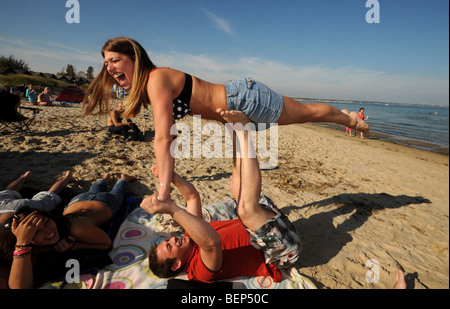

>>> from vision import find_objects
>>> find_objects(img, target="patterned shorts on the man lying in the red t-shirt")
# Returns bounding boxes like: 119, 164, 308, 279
247, 195, 301, 269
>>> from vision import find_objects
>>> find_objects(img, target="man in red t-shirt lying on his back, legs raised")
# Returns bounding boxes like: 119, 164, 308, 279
141, 111, 301, 283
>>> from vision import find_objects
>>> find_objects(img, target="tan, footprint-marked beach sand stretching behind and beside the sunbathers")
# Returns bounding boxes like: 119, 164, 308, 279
0, 105, 449, 289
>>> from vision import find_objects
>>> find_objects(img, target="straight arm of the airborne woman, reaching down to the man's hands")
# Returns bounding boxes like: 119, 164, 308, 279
147, 71, 175, 200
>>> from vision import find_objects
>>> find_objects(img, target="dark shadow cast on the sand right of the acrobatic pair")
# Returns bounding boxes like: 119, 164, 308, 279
282, 193, 431, 286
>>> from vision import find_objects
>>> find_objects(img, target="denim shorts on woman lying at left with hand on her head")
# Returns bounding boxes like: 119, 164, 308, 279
65, 179, 128, 217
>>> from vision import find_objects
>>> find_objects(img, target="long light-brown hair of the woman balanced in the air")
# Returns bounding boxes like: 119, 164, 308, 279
83, 37, 156, 119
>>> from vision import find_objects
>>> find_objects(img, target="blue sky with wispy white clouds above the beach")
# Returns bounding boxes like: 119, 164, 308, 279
0, 0, 449, 106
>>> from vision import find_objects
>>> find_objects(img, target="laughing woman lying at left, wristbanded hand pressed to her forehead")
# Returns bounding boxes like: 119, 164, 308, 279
0, 173, 136, 289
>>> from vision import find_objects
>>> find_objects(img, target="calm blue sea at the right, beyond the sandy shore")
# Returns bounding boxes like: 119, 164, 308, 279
302, 101, 449, 154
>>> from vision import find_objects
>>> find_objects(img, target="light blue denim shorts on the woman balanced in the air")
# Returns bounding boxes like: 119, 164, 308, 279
225, 77, 284, 129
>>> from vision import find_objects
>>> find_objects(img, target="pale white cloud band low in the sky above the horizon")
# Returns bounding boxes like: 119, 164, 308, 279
0, 36, 449, 106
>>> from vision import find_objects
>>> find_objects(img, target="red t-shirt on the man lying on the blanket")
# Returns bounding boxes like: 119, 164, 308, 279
184, 220, 283, 283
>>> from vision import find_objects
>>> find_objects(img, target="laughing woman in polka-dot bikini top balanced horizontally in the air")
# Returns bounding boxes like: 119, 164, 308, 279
83, 37, 369, 200
